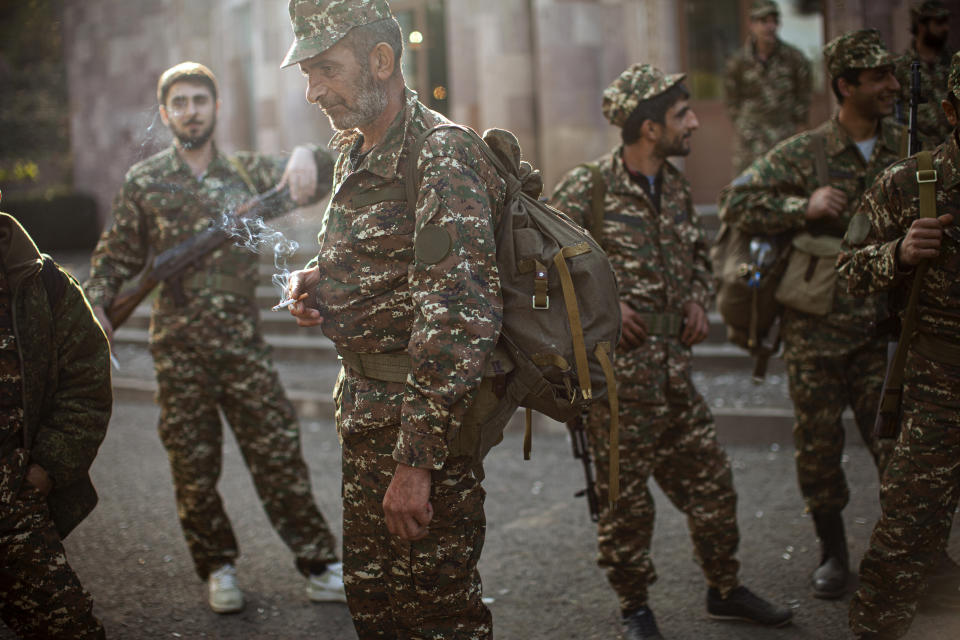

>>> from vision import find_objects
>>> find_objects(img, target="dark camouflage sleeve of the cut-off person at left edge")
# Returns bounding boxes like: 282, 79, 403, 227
30, 270, 113, 487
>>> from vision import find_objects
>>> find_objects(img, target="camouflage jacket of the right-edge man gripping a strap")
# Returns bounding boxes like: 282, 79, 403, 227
840, 136, 960, 344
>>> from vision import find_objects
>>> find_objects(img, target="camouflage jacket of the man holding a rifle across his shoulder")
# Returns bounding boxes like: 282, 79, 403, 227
85, 146, 332, 346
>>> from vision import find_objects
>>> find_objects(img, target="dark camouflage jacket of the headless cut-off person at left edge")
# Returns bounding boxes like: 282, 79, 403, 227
0, 213, 113, 537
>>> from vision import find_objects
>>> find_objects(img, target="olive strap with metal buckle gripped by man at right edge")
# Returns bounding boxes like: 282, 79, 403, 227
879, 151, 938, 424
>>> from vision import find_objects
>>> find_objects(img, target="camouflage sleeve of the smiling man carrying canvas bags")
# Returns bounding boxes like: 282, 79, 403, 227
719, 140, 814, 235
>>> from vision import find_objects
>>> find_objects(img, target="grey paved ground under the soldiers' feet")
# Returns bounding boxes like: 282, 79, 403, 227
7, 404, 960, 640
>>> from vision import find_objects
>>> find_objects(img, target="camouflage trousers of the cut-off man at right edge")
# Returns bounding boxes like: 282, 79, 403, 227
850, 353, 960, 638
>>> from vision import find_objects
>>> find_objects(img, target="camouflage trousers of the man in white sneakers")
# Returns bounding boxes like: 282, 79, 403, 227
151, 339, 337, 579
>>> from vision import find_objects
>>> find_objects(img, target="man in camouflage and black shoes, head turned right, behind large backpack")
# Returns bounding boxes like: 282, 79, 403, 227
551, 64, 792, 640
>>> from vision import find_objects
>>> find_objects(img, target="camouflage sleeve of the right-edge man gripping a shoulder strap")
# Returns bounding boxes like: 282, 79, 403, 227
837, 164, 911, 296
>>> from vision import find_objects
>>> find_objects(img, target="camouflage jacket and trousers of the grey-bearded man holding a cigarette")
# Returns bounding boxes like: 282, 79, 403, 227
314, 90, 505, 638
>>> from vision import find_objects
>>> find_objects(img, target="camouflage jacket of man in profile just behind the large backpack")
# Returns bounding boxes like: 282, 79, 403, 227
551, 147, 714, 404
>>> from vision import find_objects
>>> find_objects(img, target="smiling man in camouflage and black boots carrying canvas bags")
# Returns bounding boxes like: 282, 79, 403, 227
720, 30, 904, 598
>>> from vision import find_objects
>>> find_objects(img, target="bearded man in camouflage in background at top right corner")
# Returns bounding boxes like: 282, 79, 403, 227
896, 0, 953, 149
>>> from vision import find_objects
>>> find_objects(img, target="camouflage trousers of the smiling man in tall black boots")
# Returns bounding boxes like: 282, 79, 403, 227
786, 341, 893, 512
